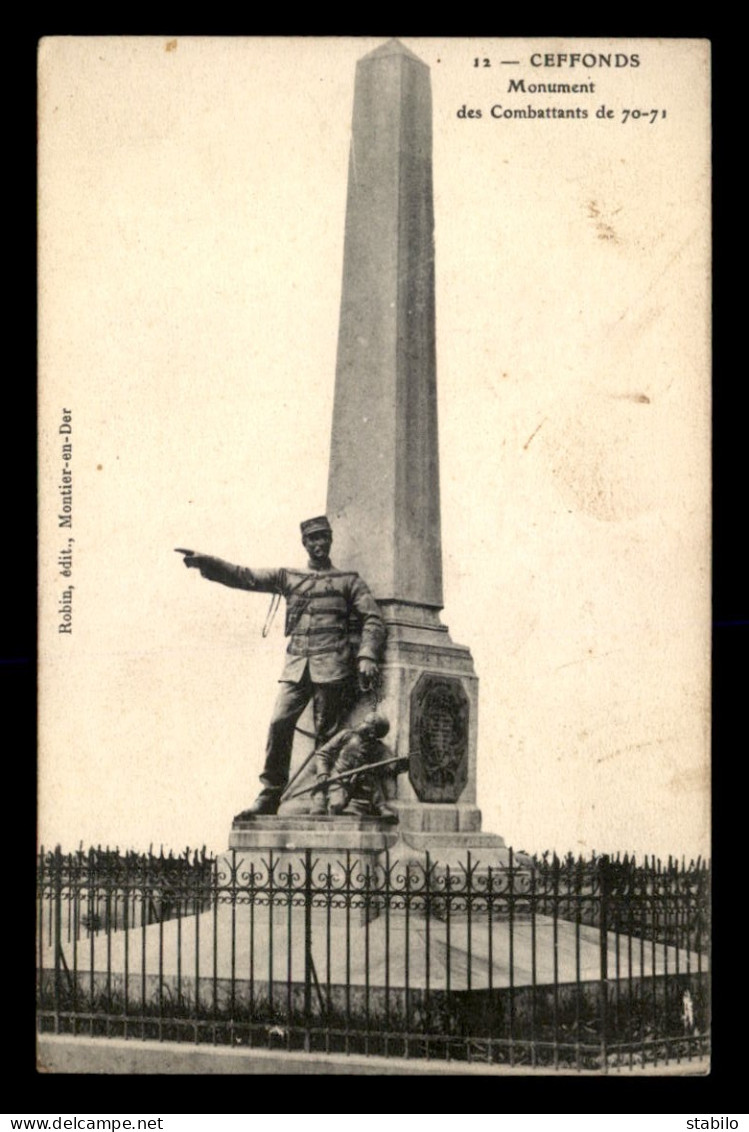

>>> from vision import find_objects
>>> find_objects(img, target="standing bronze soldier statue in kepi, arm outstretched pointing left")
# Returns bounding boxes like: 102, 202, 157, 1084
180, 515, 386, 818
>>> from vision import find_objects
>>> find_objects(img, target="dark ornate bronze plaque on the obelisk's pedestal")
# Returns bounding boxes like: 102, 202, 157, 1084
408, 672, 470, 801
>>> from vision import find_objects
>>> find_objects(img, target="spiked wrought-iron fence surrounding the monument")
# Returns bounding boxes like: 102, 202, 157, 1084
37, 849, 709, 1072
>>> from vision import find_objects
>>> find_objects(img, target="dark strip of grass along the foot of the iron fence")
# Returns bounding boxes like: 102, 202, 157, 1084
38, 980, 708, 1072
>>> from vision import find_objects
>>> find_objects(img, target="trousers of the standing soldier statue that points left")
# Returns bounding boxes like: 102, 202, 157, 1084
260, 669, 350, 790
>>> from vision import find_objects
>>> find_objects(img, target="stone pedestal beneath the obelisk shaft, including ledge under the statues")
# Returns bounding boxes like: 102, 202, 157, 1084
229, 601, 509, 869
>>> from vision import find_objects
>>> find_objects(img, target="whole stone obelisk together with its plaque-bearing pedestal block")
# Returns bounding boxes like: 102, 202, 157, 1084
327, 40, 503, 857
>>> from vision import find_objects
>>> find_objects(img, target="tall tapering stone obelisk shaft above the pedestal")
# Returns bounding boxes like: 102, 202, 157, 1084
327, 41, 442, 609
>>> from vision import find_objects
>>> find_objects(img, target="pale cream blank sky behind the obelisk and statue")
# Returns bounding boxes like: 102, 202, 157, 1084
38, 37, 711, 858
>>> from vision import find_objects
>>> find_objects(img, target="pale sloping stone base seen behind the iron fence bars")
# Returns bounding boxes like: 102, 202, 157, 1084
46, 892, 707, 991
